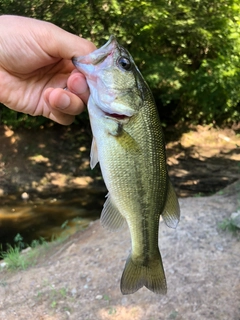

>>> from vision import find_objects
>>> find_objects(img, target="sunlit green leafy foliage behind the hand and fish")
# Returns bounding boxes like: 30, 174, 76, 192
0, 0, 240, 125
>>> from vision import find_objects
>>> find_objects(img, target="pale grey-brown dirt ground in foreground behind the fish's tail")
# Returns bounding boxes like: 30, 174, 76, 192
0, 182, 240, 320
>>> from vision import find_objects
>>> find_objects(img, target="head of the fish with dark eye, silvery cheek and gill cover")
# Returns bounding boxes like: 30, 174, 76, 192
72, 36, 144, 121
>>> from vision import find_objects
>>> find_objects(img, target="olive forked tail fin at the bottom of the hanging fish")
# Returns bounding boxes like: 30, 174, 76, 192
121, 254, 167, 294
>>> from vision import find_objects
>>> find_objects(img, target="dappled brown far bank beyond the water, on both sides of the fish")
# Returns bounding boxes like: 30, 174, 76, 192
0, 125, 240, 202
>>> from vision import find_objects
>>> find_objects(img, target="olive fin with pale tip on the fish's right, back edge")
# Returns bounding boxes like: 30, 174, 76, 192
162, 179, 180, 229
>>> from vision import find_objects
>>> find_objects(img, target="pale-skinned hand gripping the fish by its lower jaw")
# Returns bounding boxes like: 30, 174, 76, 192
0, 16, 96, 125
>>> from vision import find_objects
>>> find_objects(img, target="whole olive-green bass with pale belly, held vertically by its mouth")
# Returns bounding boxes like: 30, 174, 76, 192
72, 36, 180, 295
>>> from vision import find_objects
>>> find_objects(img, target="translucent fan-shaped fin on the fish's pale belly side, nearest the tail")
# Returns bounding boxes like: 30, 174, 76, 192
100, 194, 125, 231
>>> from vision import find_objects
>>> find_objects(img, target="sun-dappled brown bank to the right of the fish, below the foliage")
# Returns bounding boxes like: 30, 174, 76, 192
166, 126, 240, 197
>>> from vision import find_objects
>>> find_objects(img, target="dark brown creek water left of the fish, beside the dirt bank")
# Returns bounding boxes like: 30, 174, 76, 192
0, 188, 106, 250
